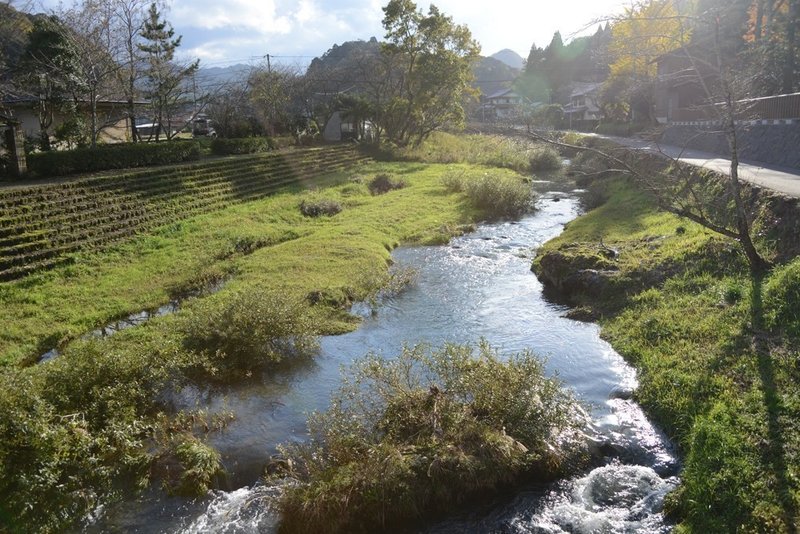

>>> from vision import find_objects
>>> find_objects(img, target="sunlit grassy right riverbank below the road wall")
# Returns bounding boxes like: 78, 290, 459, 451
534, 175, 800, 533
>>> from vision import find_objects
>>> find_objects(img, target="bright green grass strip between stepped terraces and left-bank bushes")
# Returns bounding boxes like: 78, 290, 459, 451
0, 163, 513, 365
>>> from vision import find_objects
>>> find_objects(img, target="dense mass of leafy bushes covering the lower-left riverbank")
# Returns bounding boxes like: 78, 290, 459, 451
0, 290, 317, 532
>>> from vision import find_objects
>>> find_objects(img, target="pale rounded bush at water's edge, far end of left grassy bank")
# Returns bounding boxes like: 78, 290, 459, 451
442, 169, 534, 217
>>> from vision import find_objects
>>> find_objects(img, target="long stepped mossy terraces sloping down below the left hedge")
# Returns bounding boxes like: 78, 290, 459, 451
0, 146, 367, 280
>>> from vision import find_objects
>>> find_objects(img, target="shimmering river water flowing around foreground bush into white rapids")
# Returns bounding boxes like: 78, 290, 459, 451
86, 184, 678, 533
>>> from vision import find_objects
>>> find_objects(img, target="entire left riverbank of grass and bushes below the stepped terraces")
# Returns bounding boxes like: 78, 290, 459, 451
0, 146, 544, 532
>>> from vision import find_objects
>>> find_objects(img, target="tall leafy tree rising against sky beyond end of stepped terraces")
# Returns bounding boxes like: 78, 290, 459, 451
375, 0, 480, 145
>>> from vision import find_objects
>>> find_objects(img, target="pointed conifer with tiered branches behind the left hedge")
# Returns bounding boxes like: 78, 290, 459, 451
138, 3, 199, 141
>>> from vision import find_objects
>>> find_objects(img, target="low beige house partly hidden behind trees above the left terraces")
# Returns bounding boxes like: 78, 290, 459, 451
0, 96, 147, 143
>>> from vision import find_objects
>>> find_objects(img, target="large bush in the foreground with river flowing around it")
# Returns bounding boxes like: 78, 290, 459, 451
281, 343, 585, 532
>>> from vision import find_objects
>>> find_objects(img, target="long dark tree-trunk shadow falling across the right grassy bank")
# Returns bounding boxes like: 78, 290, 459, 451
750, 275, 798, 534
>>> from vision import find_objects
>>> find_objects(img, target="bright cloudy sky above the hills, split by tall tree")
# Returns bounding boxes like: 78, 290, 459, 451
29, 0, 630, 67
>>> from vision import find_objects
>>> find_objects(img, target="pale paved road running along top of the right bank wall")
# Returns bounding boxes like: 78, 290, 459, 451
601, 136, 800, 197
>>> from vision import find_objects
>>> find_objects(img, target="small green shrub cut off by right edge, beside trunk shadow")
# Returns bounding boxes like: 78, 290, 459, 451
764, 260, 800, 337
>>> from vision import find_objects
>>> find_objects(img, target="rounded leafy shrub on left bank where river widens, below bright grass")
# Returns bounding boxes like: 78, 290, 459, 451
183, 290, 318, 379
